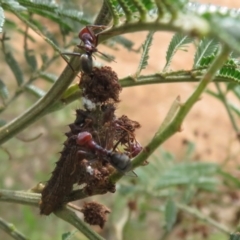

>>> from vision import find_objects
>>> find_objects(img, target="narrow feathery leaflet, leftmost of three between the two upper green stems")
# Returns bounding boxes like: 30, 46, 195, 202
136, 31, 154, 77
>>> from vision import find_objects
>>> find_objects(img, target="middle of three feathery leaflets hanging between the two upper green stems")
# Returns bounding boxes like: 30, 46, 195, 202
163, 33, 193, 72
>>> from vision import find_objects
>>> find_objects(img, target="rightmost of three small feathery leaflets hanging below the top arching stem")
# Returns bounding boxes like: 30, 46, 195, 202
193, 38, 219, 68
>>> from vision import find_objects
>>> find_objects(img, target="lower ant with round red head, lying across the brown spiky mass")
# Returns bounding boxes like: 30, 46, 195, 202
76, 132, 131, 173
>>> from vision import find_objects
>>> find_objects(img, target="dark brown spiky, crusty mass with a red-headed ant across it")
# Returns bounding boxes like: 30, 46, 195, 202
40, 67, 142, 227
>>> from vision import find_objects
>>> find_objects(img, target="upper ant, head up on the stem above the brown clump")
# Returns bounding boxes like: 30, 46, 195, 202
62, 25, 109, 74
